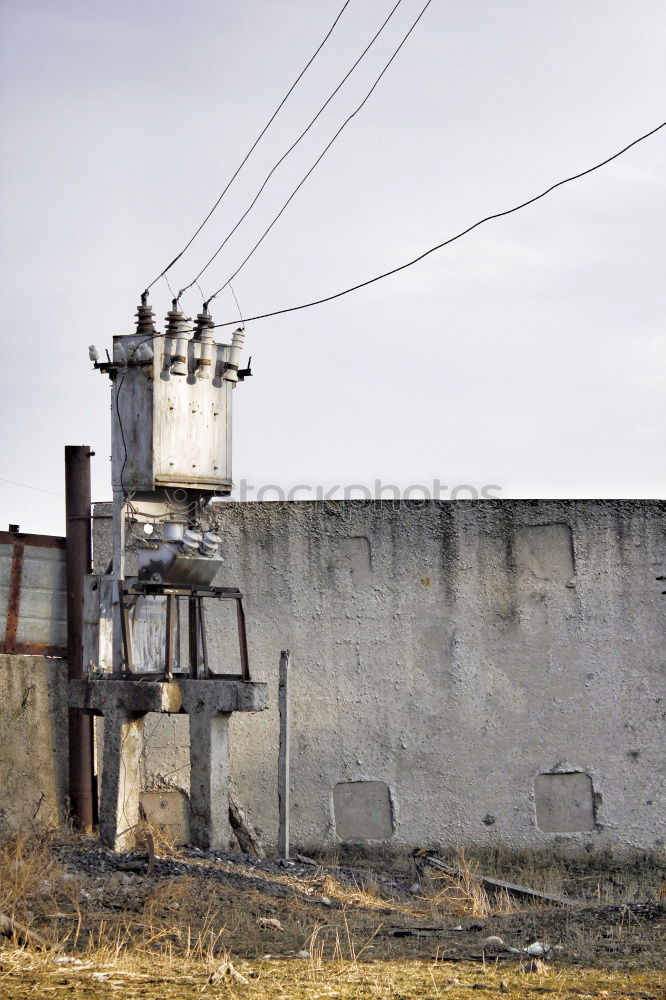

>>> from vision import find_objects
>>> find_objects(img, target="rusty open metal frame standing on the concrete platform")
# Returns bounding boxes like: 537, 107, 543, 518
119, 582, 250, 681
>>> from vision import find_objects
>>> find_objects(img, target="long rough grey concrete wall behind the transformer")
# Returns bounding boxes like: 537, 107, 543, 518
96, 500, 666, 847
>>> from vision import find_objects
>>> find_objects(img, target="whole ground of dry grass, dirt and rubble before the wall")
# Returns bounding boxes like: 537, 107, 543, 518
0, 832, 666, 1000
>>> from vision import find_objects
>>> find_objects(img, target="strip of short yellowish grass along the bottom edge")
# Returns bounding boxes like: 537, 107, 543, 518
0, 951, 664, 1000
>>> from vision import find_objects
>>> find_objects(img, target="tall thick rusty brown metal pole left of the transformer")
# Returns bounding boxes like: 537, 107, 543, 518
65, 445, 96, 830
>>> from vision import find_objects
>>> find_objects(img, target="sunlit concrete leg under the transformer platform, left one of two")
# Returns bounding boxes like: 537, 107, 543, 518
99, 709, 144, 851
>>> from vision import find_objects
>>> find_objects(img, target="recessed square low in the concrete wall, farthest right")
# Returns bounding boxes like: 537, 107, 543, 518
534, 771, 594, 833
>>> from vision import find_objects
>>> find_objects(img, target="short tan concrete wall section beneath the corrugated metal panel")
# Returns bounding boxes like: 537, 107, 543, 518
0, 655, 68, 835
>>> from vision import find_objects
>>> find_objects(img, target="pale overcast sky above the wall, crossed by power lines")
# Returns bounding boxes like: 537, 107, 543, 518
0, 0, 666, 533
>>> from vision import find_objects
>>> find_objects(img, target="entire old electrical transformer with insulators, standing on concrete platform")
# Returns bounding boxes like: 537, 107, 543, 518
85, 297, 252, 680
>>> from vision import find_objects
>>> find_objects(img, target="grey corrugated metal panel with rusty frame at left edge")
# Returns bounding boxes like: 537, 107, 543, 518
0, 531, 67, 656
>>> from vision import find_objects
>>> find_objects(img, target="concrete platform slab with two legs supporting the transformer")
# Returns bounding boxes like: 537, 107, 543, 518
69, 678, 268, 851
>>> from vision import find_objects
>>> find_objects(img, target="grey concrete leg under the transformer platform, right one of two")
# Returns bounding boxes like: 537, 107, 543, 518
189, 711, 231, 850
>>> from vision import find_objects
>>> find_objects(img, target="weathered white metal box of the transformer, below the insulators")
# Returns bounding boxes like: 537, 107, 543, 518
112, 334, 235, 494
